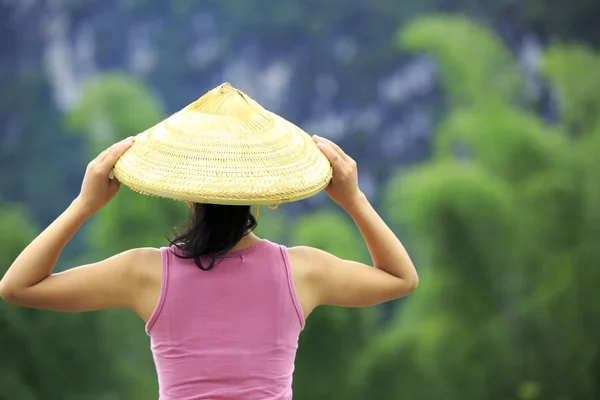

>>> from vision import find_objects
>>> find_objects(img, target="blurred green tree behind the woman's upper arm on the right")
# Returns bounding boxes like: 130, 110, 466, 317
292, 211, 373, 400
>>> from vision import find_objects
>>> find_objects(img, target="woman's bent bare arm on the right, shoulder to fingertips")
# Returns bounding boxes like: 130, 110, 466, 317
290, 137, 419, 311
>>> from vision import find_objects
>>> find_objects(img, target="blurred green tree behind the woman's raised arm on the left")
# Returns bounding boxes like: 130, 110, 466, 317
67, 73, 187, 398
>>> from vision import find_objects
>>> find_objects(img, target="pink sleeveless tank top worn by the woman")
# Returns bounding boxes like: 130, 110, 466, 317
146, 240, 304, 400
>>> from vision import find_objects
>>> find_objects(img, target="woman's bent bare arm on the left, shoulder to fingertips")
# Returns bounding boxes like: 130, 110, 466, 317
0, 136, 149, 311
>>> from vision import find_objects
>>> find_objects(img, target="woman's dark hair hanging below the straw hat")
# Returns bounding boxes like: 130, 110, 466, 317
170, 203, 257, 271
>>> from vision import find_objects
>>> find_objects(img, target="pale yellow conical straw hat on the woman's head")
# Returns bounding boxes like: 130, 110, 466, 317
114, 83, 332, 205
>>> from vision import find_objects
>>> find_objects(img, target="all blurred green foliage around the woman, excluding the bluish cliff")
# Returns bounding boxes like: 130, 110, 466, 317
0, 11, 600, 400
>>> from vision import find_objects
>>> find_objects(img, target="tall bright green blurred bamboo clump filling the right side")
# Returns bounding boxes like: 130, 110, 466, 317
355, 16, 600, 400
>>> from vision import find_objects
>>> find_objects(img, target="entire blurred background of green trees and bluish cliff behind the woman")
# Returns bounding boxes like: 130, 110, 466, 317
0, 0, 600, 400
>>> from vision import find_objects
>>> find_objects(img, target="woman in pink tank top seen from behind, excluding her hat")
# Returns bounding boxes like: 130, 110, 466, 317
0, 83, 418, 400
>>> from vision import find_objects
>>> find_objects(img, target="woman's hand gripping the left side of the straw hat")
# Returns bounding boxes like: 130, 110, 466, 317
76, 137, 133, 215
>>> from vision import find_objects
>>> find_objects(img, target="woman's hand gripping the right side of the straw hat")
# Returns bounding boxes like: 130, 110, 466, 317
313, 135, 362, 211
